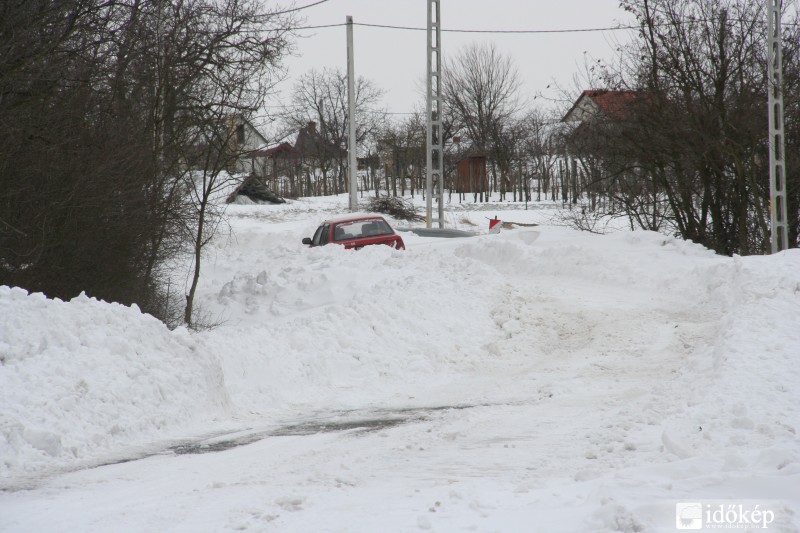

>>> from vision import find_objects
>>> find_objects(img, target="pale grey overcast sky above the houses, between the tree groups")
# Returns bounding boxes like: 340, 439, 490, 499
274, 0, 632, 117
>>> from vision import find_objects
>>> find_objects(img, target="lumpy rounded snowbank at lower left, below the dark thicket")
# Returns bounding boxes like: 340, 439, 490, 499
0, 287, 228, 475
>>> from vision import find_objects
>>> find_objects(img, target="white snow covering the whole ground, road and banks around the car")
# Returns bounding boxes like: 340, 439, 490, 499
0, 196, 800, 532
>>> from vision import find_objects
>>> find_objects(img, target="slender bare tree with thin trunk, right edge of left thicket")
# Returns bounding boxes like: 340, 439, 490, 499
164, 0, 294, 326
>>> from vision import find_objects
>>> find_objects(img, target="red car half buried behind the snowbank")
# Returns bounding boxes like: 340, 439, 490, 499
303, 215, 406, 250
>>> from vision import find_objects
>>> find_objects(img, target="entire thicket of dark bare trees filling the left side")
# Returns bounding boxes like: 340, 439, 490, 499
0, 0, 291, 319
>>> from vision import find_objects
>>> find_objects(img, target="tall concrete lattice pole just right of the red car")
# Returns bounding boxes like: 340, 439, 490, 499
425, 0, 444, 228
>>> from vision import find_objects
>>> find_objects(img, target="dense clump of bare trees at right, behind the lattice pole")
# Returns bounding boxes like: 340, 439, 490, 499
572, 0, 800, 255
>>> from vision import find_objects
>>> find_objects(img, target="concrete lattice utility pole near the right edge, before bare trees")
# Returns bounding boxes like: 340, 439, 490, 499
767, 0, 789, 254
